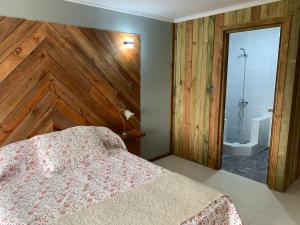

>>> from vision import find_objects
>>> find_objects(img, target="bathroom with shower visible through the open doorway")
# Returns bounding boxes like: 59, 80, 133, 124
222, 27, 281, 183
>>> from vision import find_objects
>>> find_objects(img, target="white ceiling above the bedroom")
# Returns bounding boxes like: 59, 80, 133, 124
65, 0, 278, 23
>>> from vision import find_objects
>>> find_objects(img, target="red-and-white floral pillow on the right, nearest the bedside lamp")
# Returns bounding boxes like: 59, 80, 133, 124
32, 127, 126, 176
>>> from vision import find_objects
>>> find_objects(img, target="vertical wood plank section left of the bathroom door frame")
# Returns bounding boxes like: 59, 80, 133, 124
173, 17, 215, 164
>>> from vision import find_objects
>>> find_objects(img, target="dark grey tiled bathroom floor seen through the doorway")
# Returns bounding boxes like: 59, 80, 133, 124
222, 149, 269, 183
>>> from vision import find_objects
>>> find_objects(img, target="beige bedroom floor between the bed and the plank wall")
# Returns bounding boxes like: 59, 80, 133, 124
155, 156, 300, 225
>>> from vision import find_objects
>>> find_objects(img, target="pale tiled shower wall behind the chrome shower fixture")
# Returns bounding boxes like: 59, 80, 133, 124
225, 28, 280, 141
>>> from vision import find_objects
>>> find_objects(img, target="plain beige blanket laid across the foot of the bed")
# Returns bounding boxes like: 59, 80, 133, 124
53, 173, 221, 225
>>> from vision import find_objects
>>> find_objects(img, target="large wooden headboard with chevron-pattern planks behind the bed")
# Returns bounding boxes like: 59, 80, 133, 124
0, 17, 140, 146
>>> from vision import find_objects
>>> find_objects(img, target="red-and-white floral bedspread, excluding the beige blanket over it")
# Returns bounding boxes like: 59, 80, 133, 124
0, 127, 242, 225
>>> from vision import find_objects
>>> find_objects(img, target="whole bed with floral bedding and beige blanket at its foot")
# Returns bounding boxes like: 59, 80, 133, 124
0, 127, 242, 225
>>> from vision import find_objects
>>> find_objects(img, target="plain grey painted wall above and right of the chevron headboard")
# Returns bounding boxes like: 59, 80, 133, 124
0, 0, 172, 159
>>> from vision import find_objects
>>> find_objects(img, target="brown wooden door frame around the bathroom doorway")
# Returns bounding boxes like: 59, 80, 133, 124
208, 16, 291, 189
